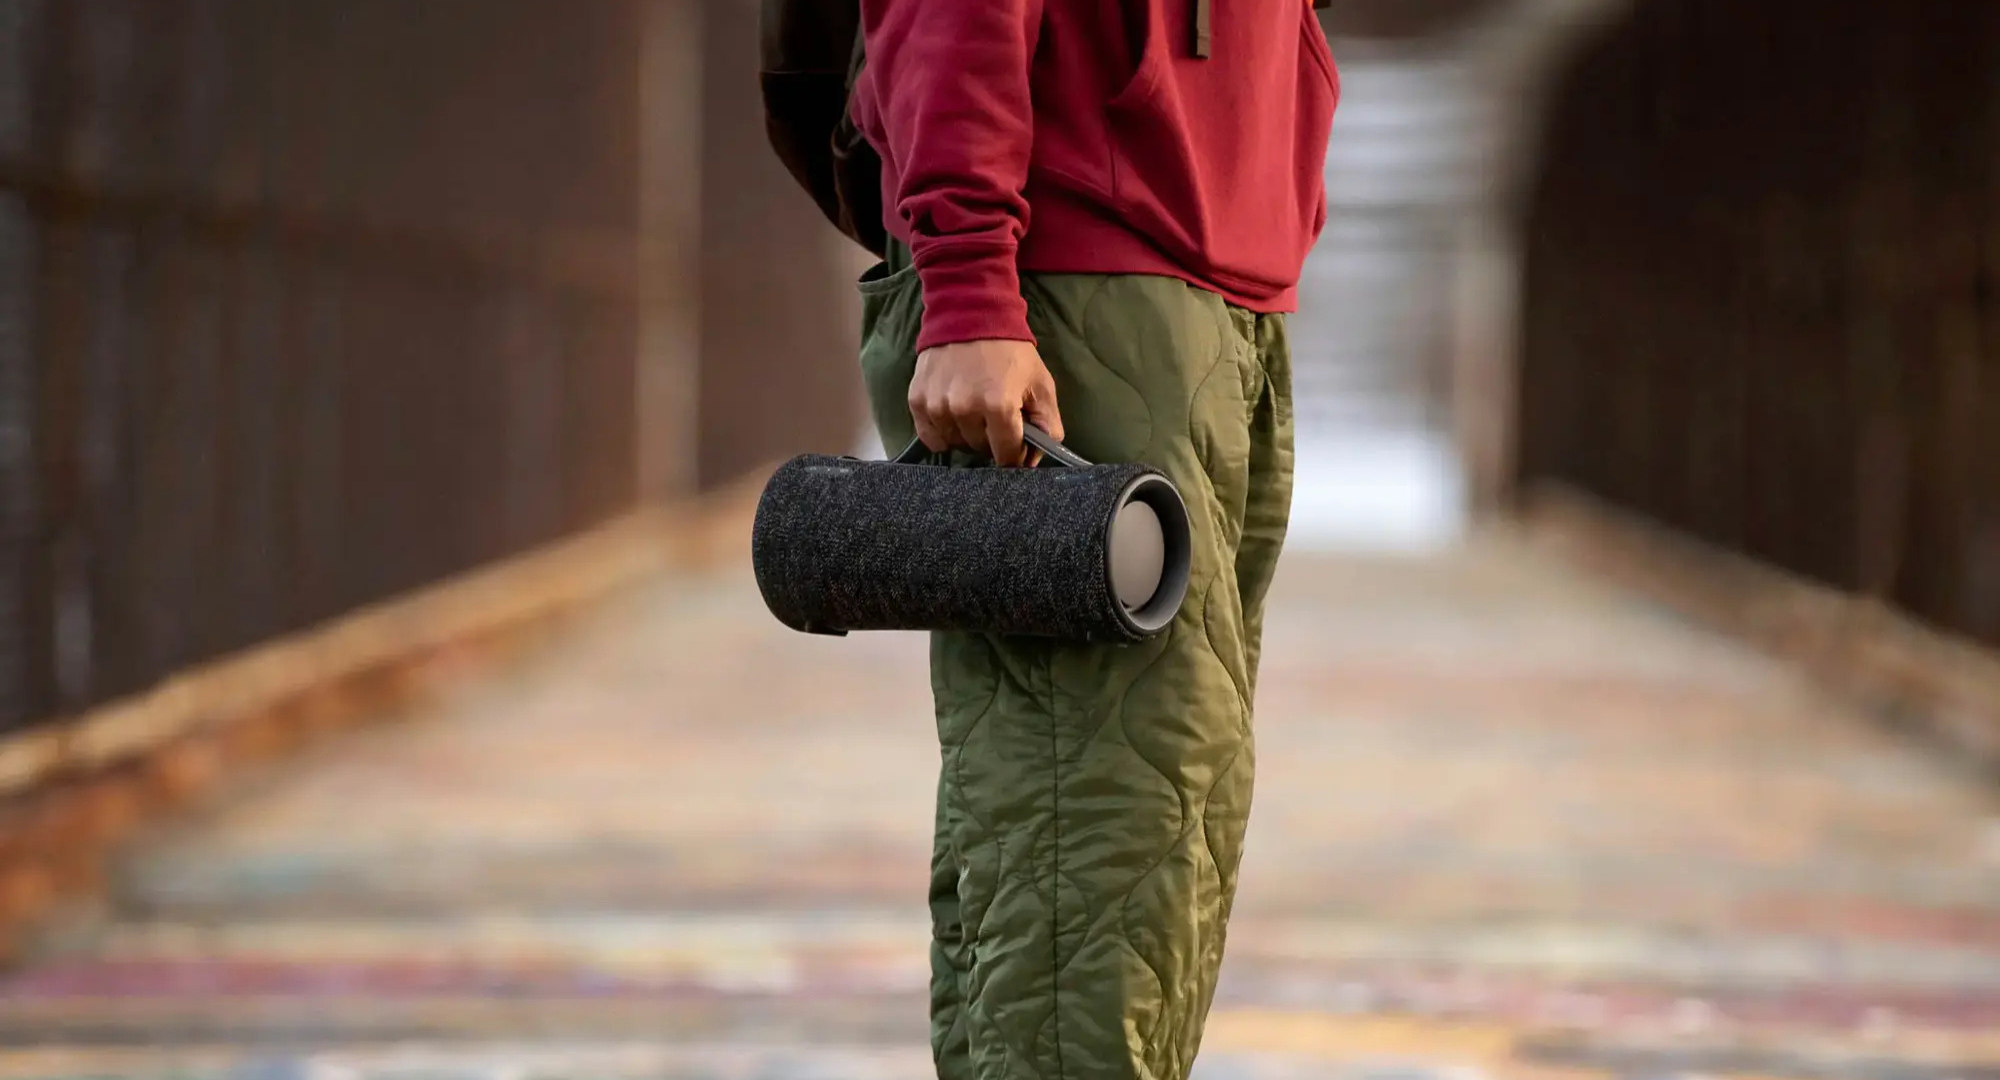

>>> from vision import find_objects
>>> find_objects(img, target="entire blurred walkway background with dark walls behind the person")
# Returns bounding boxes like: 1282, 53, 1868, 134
0, 0, 2000, 1080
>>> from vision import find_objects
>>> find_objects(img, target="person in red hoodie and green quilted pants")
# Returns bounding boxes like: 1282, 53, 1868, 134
850, 0, 1340, 1080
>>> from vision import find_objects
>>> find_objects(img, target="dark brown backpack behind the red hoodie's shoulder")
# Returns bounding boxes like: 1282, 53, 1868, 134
758, 0, 884, 258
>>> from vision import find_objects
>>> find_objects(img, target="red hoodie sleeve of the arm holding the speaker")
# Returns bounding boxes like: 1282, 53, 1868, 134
862, 0, 1044, 350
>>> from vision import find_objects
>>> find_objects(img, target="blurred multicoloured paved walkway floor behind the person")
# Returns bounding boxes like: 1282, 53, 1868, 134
0, 542, 2000, 1080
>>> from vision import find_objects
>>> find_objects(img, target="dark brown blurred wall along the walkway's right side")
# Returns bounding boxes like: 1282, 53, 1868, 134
1516, 0, 2000, 642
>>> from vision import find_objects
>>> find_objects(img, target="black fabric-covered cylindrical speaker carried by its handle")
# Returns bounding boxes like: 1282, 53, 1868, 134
750, 428, 1192, 644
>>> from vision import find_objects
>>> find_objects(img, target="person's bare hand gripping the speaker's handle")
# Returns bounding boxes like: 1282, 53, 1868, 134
910, 340, 1062, 466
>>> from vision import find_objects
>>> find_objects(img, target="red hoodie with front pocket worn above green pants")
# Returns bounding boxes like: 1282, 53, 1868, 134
852, 0, 1340, 348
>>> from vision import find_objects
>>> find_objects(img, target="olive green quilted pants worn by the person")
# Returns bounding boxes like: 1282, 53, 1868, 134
862, 250, 1292, 1080
